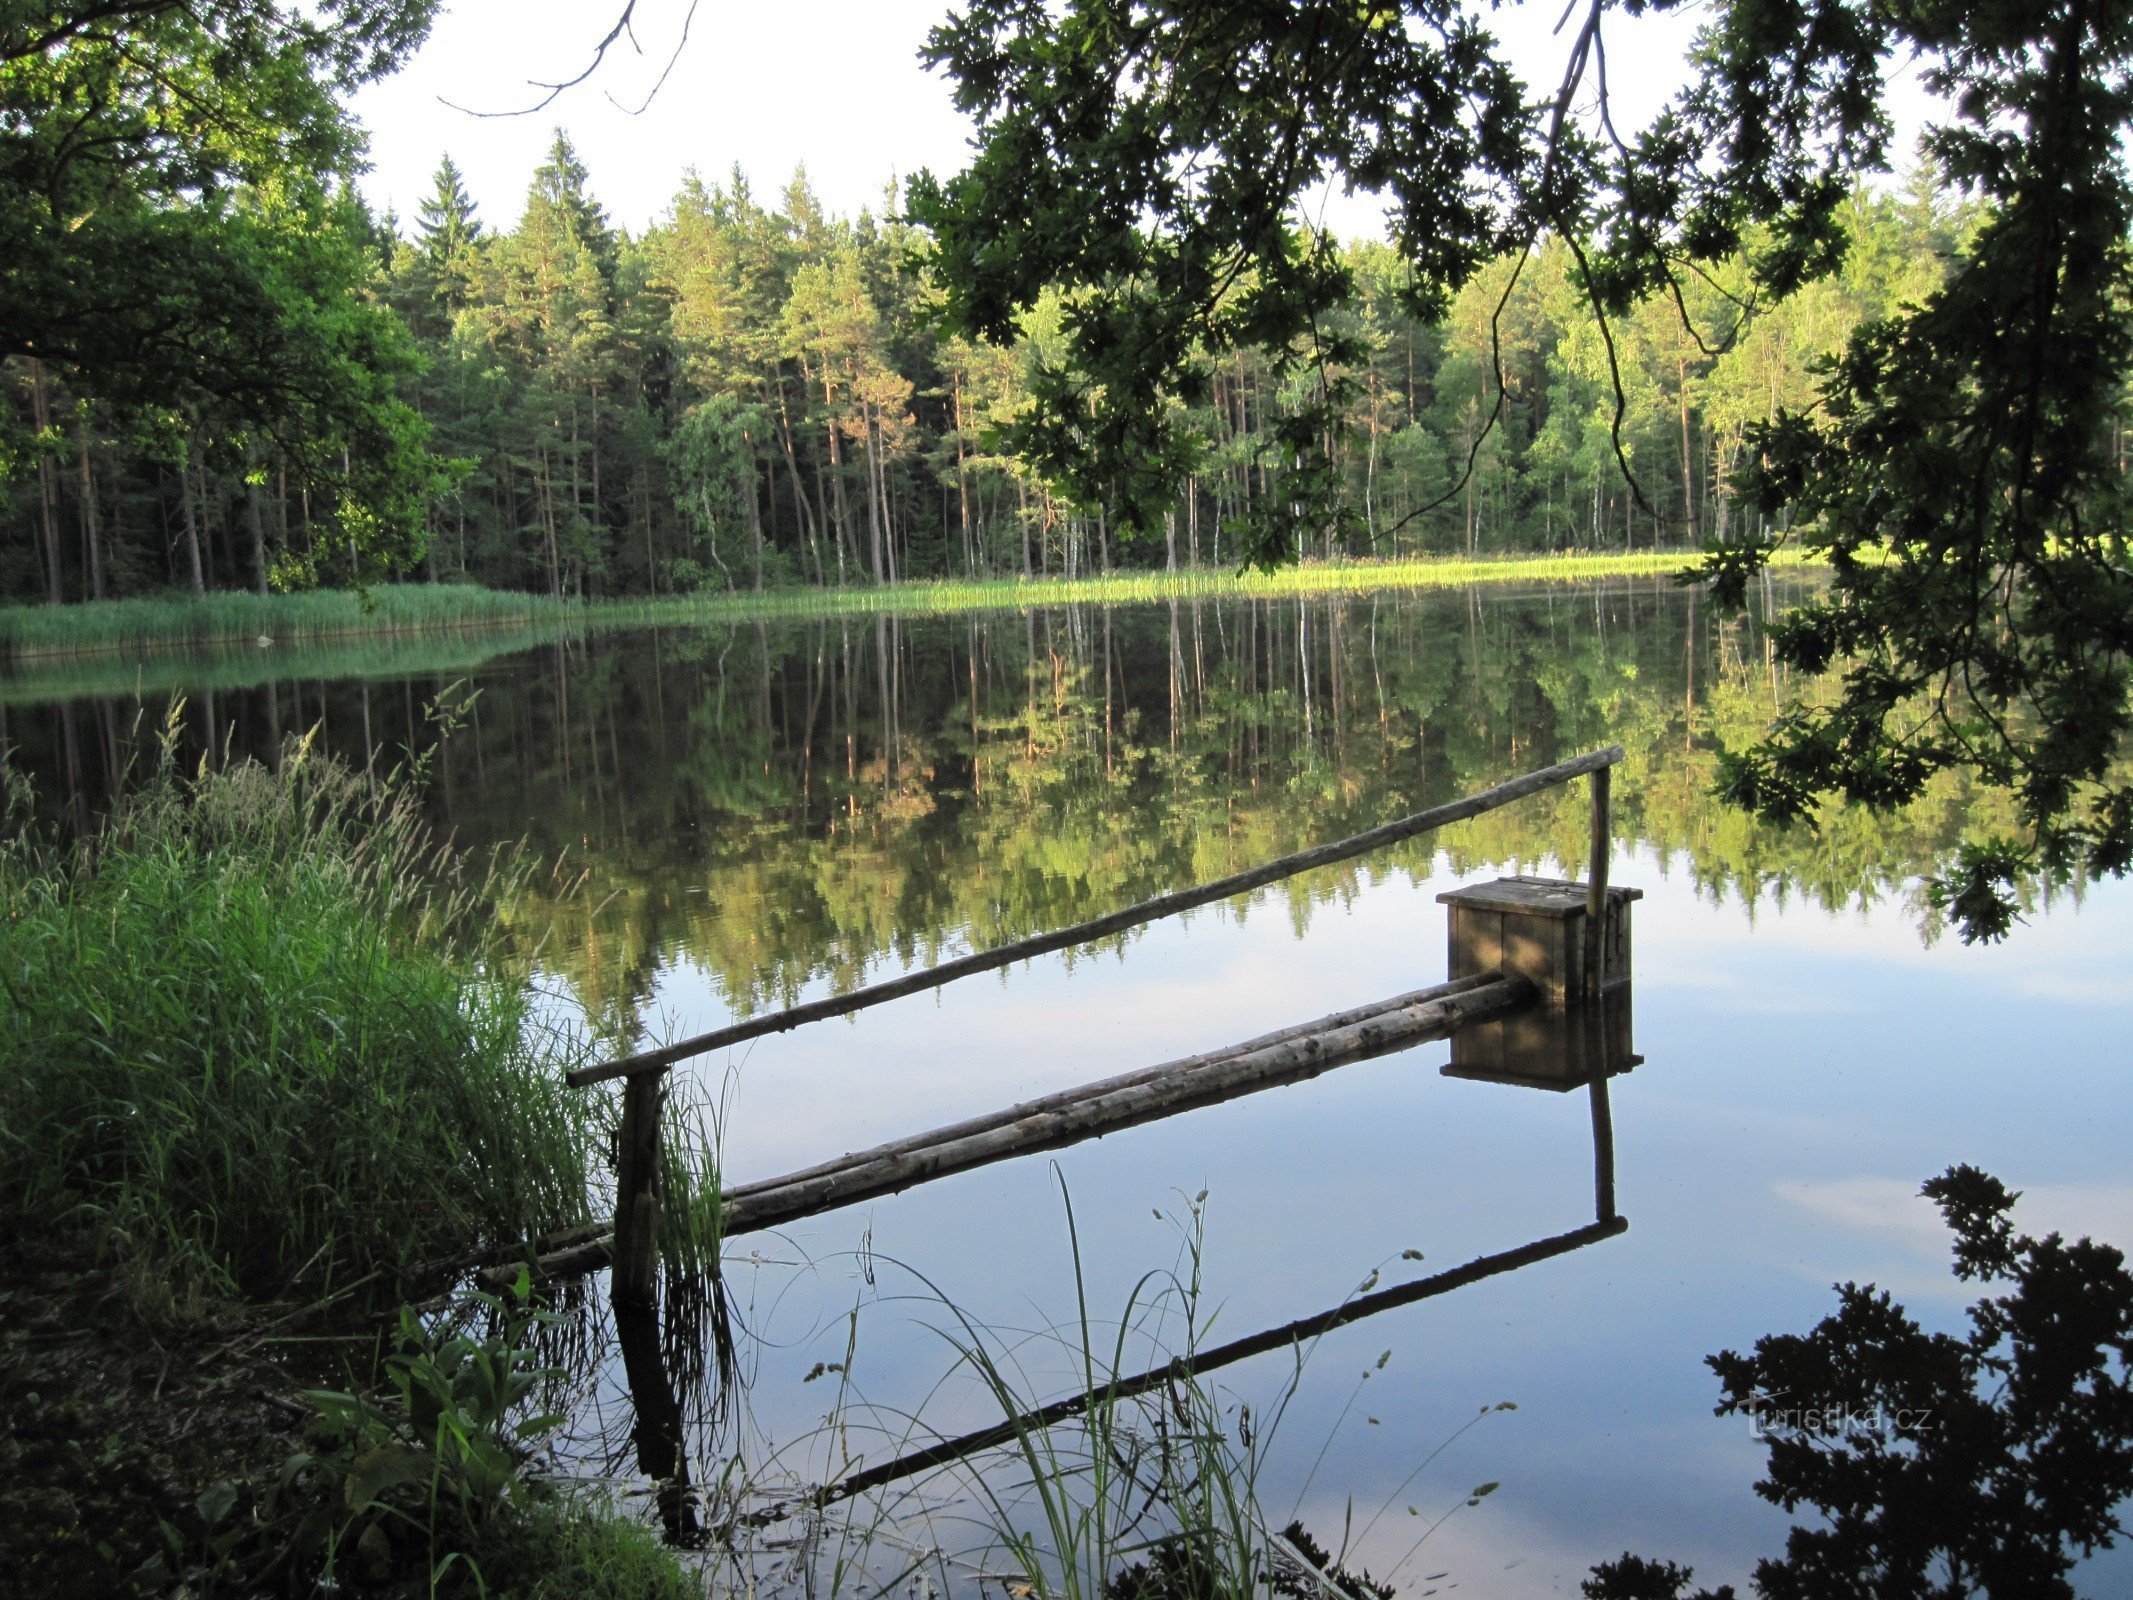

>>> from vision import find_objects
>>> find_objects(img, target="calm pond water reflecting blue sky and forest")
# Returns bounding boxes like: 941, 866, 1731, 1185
0, 582, 2133, 1596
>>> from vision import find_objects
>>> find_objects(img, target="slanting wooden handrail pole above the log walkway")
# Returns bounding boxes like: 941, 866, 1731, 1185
567, 745, 1623, 1088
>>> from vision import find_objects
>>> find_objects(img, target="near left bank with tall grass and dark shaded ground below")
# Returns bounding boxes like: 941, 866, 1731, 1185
0, 745, 695, 1600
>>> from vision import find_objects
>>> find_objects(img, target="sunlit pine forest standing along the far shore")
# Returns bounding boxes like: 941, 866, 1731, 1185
0, 132, 1975, 602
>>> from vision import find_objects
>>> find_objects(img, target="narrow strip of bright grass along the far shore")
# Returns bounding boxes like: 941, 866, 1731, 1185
0, 550, 1817, 663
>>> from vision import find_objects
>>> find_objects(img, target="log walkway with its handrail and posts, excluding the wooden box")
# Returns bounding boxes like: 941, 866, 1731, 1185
507, 745, 1623, 1303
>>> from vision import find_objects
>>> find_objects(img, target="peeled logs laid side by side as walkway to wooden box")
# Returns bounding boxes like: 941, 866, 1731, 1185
493, 977, 1534, 1278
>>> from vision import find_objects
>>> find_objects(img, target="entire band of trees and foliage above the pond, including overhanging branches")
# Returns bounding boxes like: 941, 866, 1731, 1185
0, 0, 2133, 939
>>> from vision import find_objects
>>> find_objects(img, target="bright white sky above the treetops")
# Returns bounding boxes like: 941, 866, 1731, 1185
354, 0, 1702, 235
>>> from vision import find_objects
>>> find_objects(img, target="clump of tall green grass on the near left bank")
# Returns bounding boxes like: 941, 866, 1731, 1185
0, 721, 599, 1312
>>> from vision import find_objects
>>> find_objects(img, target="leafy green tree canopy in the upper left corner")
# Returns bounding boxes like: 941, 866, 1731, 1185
0, 0, 435, 597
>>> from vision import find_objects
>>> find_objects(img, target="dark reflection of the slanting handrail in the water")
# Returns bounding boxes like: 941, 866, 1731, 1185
734, 1216, 1630, 1527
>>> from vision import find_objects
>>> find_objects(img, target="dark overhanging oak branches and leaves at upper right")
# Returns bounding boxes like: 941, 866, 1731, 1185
911, 0, 2133, 939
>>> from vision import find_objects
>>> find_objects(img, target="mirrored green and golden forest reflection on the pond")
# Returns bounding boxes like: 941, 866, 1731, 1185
0, 582, 2022, 1066
